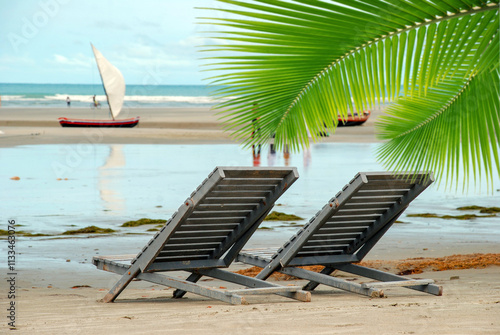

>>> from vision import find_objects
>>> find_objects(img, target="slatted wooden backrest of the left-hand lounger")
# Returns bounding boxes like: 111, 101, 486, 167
132, 167, 298, 271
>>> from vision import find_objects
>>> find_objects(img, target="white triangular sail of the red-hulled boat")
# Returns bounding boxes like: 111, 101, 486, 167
91, 44, 125, 119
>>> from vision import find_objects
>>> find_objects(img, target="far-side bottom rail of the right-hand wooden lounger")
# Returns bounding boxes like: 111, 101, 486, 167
335, 264, 443, 296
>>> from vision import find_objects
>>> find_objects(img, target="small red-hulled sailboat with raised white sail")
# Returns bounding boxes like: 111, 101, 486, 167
59, 44, 139, 128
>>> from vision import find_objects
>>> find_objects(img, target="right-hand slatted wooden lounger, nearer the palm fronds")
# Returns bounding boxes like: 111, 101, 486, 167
237, 172, 442, 297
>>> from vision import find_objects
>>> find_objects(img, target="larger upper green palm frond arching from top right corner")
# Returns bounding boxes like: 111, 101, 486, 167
199, 0, 500, 189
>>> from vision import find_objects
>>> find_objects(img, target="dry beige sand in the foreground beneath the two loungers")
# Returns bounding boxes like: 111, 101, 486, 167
7, 267, 500, 335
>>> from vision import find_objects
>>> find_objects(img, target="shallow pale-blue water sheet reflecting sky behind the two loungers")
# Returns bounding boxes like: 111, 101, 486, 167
0, 143, 500, 239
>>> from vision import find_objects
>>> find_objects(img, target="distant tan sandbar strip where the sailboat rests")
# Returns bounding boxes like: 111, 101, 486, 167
0, 107, 382, 147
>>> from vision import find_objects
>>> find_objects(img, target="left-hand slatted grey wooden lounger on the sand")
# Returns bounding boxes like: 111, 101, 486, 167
93, 167, 311, 304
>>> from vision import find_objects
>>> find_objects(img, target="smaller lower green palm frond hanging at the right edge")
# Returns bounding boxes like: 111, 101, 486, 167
378, 69, 500, 190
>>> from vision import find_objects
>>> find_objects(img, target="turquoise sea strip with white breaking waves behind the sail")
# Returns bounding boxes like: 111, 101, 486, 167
0, 83, 223, 108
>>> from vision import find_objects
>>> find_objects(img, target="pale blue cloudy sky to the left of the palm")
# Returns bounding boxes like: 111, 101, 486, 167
0, 0, 221, 85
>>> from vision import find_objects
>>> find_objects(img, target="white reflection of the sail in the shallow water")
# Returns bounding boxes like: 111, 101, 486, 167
98, 144, 126, 212
